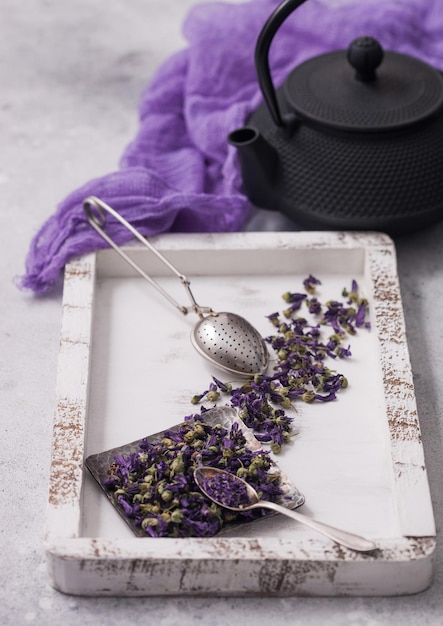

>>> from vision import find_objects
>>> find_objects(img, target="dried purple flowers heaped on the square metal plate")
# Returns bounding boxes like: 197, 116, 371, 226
104, 413, 282, 537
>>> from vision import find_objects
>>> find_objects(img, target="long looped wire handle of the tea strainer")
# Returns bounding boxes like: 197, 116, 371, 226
83, 196, 212, 317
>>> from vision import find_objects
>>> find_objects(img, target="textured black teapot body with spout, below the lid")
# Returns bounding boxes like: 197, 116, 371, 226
230, 81, 443, 234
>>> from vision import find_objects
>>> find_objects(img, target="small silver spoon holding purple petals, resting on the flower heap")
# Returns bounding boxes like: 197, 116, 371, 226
194, 466, 377, 552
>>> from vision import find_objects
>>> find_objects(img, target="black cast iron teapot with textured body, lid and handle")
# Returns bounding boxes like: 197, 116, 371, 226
228, 0, 443, 234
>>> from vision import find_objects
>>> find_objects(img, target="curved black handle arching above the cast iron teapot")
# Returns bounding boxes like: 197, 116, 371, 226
255, 0, 306, 126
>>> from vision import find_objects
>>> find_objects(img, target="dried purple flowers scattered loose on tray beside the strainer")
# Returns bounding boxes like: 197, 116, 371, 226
192, 275, 370, 453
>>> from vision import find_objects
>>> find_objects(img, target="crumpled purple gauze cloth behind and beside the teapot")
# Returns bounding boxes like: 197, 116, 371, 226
20, 0, 443, 294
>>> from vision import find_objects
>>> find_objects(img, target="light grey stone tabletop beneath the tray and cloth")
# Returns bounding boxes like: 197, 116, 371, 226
0, 0, 443, 626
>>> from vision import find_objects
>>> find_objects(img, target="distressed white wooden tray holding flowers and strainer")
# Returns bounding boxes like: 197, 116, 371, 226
46, 232, 435, 596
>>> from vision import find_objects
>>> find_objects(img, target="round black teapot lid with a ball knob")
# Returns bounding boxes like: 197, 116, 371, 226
284, 37, 443, 132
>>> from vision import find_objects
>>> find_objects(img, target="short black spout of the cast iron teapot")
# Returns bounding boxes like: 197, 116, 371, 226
228, 126, 278, 208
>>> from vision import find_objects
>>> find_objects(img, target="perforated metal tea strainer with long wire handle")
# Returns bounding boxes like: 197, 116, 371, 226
83, 196, 269, 377
